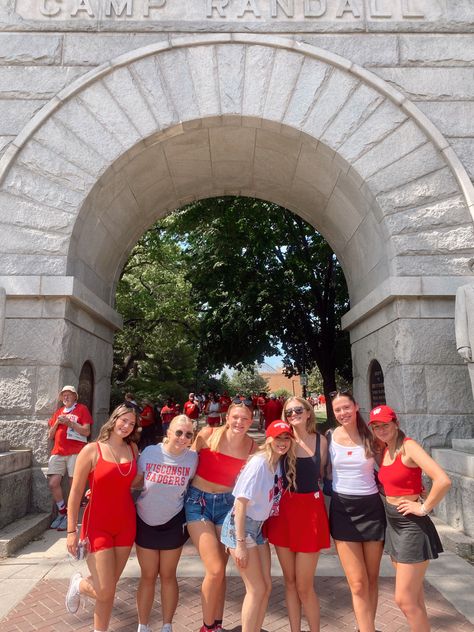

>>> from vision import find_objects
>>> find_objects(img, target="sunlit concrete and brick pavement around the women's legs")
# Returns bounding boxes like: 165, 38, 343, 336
0, 531, 474, 632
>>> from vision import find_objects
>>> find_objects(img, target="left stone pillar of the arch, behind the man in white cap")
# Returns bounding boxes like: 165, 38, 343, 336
0, 277, 120, 510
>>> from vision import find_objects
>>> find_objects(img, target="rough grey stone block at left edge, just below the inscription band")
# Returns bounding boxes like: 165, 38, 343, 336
0, 33, 62, 65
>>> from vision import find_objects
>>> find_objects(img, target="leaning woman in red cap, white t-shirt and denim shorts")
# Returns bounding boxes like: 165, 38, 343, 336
221, 419, 296, 632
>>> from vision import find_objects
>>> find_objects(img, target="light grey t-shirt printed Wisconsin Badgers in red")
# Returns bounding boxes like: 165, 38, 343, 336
137, 443, 198, 526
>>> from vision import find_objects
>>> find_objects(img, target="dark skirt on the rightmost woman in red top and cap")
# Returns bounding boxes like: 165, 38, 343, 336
385, 501, 443, 564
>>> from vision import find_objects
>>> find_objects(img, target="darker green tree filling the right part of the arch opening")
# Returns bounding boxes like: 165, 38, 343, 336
162, 197, 351, 392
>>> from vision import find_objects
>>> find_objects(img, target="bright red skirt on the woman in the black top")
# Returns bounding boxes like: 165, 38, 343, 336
264, 491, 330, 553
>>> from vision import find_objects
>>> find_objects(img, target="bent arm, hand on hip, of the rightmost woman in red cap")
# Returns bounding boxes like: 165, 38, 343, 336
398, 440, 451, 516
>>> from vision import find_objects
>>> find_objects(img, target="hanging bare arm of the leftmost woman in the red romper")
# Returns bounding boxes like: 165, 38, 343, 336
66, 443, 97, 555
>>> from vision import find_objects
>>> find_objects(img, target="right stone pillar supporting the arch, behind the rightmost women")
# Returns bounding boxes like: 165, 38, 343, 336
350, 297, 474, 449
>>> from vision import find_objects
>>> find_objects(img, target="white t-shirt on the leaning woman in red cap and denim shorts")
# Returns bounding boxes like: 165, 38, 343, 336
232, 454, 281, 520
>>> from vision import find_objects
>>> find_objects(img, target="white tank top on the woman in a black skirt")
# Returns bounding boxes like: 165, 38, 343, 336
329, 437, 379, 496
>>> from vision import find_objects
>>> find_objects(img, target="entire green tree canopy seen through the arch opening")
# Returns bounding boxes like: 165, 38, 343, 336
114, 197, 351, 402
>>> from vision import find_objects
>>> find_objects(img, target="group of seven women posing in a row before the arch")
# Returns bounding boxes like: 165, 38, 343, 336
66, 391, 450, 632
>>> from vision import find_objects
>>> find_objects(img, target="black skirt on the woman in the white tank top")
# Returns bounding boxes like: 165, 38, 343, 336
329, 491, 385, 542
